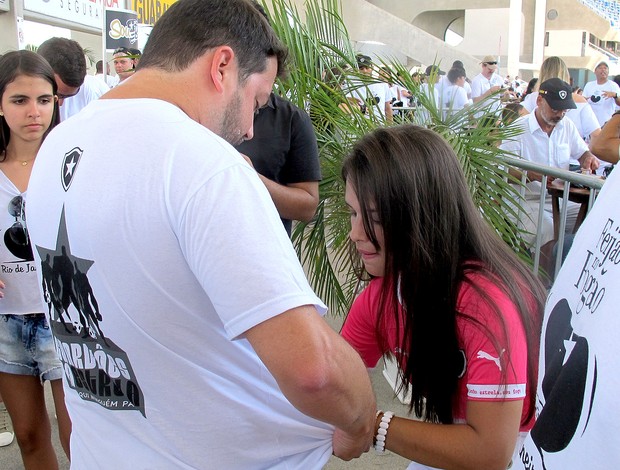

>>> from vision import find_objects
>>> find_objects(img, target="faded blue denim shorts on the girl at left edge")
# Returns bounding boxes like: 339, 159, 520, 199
0, 313, 62, 382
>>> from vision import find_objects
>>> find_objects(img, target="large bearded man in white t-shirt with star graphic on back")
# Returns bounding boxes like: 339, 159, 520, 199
28, 0, 376, 470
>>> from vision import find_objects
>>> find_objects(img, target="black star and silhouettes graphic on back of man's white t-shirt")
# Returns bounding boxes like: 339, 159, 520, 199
36, 209, 146, 417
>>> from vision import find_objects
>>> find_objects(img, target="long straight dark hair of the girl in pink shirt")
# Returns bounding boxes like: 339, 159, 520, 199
342, 125, 545, 423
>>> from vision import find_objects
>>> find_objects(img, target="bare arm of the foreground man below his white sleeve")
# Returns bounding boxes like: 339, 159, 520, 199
246, 306, 376, 436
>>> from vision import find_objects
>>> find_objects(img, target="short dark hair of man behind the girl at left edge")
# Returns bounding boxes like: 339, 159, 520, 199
37, 38, 86, 88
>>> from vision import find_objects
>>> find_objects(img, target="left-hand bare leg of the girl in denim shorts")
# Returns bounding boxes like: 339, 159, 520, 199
0, 372, 58, 470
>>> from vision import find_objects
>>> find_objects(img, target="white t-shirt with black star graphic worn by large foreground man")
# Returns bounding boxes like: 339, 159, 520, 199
28, 99, 333, 469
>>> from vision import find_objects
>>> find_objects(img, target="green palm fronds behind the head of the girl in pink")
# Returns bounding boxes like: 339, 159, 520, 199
265, 0, 524, 314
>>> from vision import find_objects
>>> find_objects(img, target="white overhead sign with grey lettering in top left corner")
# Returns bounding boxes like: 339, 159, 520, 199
24, 0, 124, 29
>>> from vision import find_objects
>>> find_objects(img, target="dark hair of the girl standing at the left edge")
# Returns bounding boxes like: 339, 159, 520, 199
0, 50, 60, 155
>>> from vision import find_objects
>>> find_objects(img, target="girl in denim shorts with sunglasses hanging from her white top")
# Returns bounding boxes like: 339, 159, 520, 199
0, 51, 71, 469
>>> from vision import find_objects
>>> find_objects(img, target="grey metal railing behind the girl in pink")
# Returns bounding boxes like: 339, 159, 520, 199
499, 155, 605, 279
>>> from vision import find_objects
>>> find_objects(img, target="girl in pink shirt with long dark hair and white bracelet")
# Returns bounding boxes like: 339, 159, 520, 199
342, 125, 545, 470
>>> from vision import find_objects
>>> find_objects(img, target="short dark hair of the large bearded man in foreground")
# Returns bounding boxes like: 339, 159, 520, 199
138, 0, 287, 81
